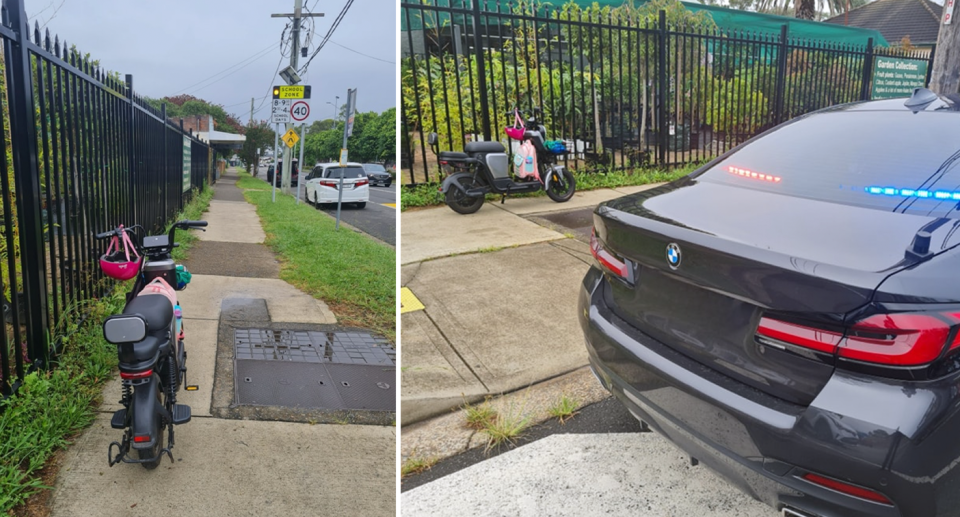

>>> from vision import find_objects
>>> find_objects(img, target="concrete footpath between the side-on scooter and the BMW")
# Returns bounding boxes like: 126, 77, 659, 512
400, 185, 653, 424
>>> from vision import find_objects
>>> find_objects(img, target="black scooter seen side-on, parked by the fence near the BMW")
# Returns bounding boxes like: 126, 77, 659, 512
427, 108, 577, 214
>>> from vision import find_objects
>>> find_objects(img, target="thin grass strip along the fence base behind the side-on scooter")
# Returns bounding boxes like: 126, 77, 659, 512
400, 163, 701, 211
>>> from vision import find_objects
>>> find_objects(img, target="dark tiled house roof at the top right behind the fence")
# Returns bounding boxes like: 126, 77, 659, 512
824, 0, 943, 45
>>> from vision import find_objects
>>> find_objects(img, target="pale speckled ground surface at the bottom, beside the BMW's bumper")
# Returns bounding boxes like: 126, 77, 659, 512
400, 433, 776, 517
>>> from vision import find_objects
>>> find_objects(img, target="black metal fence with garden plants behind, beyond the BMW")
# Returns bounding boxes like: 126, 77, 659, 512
400, 0, 933, 184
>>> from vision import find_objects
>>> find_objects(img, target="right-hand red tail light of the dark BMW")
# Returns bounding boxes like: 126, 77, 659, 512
757, 312, 960, 366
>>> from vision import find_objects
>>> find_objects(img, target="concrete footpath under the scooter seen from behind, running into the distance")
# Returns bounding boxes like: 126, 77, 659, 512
50, 171, 397, 517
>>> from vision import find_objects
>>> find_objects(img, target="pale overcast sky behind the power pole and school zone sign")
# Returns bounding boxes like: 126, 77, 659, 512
25, 0, 397, 123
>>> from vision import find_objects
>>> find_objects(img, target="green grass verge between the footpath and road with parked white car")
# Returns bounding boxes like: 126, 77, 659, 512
244, 178, 397, 340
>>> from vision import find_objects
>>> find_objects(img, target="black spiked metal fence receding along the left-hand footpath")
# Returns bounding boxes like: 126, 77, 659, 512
0, 0, 213, 398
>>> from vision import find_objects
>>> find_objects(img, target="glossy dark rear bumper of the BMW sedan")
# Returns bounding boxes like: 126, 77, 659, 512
578, 267, 960, 517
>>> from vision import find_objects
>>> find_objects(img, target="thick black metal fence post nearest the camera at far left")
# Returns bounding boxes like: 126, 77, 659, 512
4, 0, 50, 366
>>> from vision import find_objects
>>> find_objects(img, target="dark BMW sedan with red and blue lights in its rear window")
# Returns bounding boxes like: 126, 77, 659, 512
578, 90, 960, 517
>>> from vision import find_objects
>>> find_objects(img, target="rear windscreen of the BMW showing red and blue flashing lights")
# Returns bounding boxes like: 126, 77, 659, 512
697, 111, 960, 217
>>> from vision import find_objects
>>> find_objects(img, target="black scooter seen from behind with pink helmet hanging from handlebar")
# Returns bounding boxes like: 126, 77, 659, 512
96, 221, 207, 470
